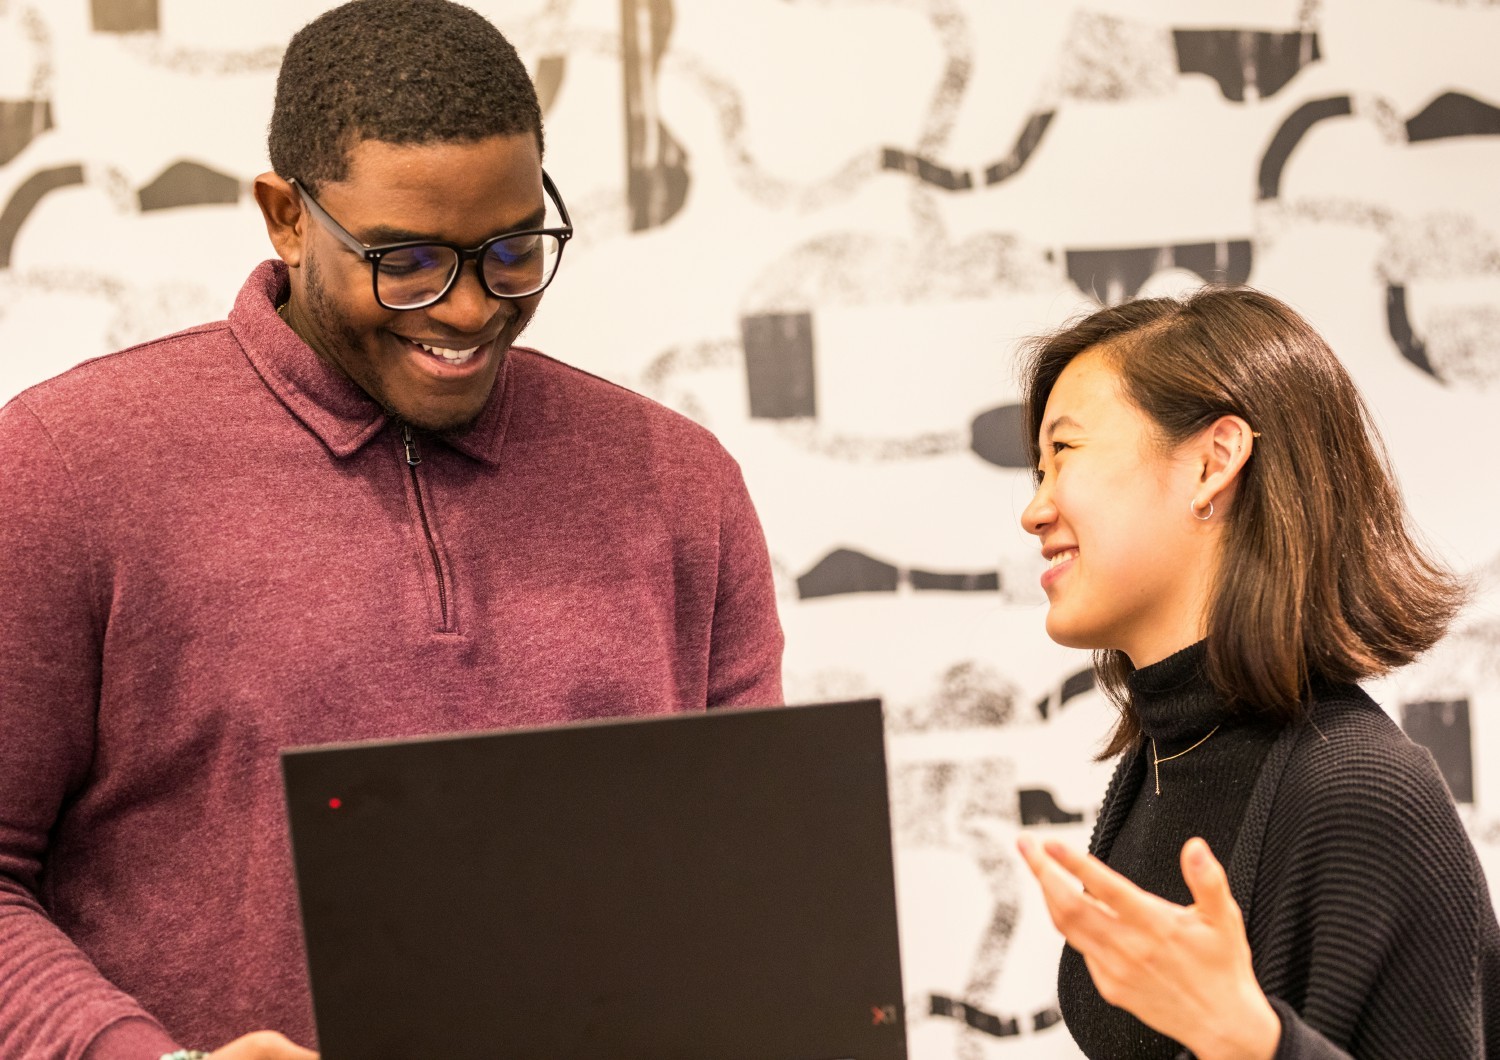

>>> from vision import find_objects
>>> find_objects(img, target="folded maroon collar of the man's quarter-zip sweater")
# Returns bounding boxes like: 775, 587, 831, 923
230, 258, 513, 465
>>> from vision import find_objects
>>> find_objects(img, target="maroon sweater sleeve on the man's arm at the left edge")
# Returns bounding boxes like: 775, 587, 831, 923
0, 399, 174, 1060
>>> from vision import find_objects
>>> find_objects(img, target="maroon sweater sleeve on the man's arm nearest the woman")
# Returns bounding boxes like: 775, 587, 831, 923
708, 453, 786, 708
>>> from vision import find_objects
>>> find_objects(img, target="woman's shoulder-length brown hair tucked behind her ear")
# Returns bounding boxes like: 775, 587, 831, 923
1022, 286, 1466, 757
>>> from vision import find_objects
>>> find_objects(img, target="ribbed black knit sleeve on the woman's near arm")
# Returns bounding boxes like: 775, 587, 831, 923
1251, 706, 1497, 1060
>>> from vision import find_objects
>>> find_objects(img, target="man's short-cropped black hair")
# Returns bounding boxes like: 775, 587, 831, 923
269, 0, 542, 193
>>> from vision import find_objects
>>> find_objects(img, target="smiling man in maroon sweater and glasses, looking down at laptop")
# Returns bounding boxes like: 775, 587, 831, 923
0, 0, 782, 1060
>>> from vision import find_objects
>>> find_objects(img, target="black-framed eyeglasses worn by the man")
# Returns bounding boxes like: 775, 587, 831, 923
288, 171, 573, 310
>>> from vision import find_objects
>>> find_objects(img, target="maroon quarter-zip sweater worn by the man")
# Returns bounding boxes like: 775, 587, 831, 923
0, 262, 782, 1060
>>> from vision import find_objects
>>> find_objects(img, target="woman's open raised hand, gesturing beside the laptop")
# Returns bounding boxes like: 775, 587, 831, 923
1019, 835, 1281, 1060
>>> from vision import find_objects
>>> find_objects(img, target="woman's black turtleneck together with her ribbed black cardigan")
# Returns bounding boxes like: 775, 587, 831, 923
1058, 642, 1500, 1060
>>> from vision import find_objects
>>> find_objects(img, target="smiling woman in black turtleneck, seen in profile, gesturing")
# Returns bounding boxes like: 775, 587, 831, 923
1022, 288, 1500, 1060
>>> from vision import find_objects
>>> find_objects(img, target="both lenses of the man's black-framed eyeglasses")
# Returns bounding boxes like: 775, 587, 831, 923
375, 232, 563, 309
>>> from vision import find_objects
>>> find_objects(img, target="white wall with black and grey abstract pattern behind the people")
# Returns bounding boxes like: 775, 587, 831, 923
0, 0, 1500, 1060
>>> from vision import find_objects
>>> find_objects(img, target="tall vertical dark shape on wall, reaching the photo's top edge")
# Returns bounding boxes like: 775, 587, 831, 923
620, 0, 689, 232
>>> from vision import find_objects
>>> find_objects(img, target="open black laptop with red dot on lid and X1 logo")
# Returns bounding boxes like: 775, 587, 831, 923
282, 700, 906, 1060
